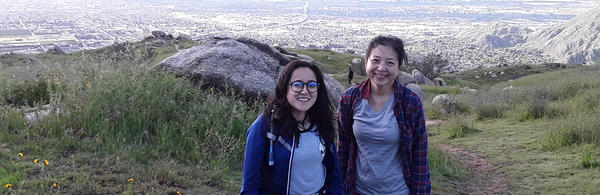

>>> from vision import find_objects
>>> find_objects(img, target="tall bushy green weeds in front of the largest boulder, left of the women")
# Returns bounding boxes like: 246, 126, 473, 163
63, 72, 259, 166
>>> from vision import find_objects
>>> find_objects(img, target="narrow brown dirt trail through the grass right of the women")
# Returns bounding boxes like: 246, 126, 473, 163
425, 120, 509, 195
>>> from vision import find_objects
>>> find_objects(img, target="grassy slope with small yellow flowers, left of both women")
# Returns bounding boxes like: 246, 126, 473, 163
0, 38, 260, 194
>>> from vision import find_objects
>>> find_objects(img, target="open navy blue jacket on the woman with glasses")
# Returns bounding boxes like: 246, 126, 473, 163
240, 114, 343, 195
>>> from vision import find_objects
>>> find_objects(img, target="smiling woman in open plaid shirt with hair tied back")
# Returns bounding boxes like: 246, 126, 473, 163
338, 36, 431, 194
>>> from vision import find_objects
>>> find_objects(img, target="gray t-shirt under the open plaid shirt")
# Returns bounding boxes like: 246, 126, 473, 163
352, 97, 409, 195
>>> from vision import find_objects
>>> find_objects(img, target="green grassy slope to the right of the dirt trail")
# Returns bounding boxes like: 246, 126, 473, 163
430, 67, 600, 194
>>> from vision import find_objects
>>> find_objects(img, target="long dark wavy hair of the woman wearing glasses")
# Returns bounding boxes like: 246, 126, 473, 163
263, 60, 335, 146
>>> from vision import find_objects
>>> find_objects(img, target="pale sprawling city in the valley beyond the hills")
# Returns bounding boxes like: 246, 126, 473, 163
0, 0, 600, 70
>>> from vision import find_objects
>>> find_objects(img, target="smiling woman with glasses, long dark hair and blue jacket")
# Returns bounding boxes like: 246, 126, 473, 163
240, 61, 343, 195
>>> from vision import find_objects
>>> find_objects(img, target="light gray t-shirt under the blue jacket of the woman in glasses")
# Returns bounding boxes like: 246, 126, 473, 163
290, 125, 326, 194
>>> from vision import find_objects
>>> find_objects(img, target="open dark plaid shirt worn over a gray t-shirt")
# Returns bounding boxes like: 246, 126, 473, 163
338, 80, 431, 194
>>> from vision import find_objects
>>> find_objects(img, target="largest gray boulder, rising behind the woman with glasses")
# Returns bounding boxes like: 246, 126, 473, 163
155, 37, 343, 102
